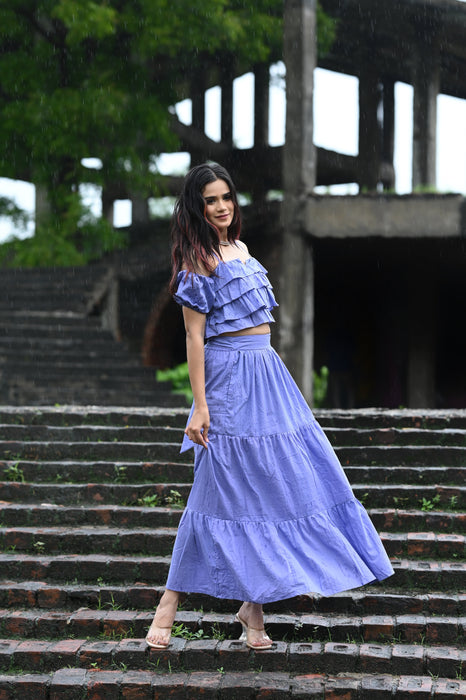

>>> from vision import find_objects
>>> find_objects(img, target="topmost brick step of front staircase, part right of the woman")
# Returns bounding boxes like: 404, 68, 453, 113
314, 408, 466, 430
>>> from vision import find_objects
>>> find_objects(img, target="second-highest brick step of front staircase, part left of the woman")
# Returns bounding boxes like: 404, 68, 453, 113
0, 424, 183, 444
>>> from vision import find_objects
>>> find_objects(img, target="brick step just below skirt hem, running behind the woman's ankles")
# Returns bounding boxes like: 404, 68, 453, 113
0, 580, 466, 616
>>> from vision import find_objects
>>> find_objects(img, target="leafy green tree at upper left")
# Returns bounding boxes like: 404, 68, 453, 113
0, 0, 334, 263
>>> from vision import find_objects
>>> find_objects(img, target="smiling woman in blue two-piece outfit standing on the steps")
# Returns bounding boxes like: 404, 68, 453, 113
146, 164, 393, 650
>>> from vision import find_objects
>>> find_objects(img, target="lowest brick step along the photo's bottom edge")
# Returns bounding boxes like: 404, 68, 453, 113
0, 668, 466, 700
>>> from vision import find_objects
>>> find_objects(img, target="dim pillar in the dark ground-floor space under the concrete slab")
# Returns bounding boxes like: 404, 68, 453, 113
407, 275, 437, 408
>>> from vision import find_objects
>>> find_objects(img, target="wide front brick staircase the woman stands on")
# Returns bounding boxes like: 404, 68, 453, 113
0, 406, 466, 700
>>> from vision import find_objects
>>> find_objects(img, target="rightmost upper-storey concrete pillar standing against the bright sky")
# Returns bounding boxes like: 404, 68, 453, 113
413, 39, 440, 190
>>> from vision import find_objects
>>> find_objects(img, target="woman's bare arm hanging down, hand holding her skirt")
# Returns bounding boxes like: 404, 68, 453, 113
183, 306, 210, 448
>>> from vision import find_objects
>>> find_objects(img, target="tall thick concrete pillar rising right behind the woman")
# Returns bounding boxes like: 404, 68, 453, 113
280, 0, 317, 402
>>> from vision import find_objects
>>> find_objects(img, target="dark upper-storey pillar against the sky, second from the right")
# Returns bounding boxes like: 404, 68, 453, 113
358, 62, 382, 192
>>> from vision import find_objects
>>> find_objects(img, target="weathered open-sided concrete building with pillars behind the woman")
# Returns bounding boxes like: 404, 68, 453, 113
139, 0, 466, 408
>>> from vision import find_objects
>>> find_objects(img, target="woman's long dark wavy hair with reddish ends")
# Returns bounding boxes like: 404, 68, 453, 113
169, 163, 241, 294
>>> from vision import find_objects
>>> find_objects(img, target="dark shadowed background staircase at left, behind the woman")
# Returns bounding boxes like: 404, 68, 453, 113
0, 265, 180, 406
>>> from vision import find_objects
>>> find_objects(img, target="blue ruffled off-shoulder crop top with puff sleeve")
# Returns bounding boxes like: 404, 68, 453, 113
173, 257, 278, 338
